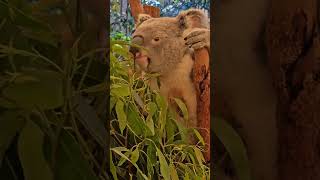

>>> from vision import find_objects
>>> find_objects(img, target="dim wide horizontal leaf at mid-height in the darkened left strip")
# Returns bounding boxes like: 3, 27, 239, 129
3, 69, 64, 109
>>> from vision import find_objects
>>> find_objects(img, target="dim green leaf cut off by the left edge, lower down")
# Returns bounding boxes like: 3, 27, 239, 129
0, 110, 24, 166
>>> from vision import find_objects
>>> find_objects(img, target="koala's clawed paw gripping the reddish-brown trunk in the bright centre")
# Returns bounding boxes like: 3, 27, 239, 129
184, 28, 210, 50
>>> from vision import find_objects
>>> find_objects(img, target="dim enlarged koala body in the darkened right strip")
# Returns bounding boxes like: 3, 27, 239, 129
213, 0, 278, 180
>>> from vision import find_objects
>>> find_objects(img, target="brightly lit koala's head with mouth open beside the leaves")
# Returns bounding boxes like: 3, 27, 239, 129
130, 9, 207, 74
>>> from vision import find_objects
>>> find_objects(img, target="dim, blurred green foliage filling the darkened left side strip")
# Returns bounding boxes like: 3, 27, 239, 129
0, 0, 108, 180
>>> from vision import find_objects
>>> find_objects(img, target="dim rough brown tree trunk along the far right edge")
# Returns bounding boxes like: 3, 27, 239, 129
266, 0, 320, 180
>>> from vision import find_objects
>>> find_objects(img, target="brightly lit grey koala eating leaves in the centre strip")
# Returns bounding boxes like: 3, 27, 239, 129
130, 9, 210, 134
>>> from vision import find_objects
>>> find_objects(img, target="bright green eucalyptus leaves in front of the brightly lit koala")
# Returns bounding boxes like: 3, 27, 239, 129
110, 41, 210, 180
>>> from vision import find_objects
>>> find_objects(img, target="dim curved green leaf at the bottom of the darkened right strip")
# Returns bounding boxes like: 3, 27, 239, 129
213, 117, 251, 180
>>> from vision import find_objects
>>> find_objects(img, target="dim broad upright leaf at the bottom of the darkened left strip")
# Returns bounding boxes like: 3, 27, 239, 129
18, 120, 53, 180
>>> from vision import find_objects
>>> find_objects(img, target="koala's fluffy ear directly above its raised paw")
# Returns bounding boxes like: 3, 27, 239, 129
177, 9, 209, 29
